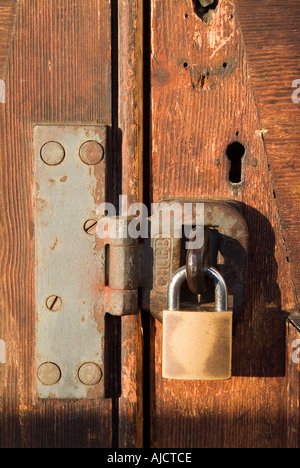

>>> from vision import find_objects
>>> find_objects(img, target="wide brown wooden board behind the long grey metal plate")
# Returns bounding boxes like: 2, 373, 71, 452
0, 0, 112, 448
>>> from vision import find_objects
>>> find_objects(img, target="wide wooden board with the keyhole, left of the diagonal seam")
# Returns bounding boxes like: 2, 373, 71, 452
151, 0, 296, 448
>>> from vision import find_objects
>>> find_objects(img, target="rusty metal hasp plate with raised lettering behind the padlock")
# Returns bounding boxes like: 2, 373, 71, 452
147, 199, 248, 322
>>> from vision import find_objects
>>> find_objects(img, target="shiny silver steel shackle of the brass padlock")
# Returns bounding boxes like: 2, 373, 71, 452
168, 266, 228, 312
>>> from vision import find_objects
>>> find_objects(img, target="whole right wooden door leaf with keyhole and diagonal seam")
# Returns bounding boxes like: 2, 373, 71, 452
149, 0, 300, 448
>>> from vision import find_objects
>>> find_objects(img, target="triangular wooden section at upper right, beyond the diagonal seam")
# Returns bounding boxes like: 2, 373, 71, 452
237, 0, 300, 308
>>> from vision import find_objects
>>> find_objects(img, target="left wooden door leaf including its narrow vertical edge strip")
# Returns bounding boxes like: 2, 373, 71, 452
0, 0, 142, 448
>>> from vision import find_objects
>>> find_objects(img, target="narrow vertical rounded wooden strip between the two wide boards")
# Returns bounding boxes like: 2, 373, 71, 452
118, 0, 143, 448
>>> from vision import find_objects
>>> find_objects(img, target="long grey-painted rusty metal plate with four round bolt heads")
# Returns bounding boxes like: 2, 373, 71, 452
34, 125, 107, 399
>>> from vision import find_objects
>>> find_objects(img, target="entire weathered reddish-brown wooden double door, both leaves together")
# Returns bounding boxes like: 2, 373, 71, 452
0, 0, 300, 448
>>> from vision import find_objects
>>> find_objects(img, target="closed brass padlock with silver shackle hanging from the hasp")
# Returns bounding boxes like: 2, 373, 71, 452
162, 267, 233, 380
